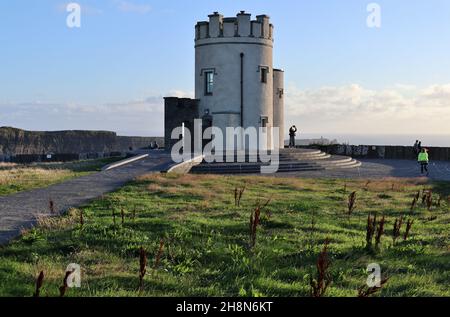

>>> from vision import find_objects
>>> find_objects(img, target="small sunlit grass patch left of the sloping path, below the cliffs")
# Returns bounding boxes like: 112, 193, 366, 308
0, 158, 120, 196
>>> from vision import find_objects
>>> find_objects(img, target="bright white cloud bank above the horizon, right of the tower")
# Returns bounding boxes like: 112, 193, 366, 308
286, 84, 450, 135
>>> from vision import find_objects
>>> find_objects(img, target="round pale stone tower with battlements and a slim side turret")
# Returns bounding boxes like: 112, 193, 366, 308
195, 11, 284, 149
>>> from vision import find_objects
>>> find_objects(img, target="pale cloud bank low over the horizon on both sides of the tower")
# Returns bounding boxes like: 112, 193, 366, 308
0, 84, 450, 137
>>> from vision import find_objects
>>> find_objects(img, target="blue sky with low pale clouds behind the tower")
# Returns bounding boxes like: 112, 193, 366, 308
0, 0, 450, 146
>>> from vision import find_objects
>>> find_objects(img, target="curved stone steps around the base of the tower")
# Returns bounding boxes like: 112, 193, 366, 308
191, 149, 361, 174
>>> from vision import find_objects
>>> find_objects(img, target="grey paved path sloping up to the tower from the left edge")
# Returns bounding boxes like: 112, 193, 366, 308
0, 153, 171, 245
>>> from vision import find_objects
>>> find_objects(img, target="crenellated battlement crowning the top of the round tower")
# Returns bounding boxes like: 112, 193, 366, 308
195, 11, 273, 41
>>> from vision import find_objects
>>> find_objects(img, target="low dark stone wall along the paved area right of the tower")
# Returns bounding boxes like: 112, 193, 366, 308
307, 144, 450, 161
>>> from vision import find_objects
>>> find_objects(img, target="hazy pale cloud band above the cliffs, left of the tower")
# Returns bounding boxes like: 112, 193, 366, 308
0, 92, 170, 136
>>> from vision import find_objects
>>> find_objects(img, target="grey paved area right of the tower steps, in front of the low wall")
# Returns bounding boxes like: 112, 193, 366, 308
276, 160, 450, 181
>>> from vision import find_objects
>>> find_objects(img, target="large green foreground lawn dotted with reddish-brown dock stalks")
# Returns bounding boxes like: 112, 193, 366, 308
0, 174, 450, 296
